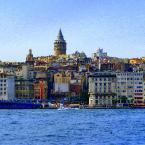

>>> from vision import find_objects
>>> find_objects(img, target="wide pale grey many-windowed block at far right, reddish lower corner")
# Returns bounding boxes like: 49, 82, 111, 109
116, 72, 144, 105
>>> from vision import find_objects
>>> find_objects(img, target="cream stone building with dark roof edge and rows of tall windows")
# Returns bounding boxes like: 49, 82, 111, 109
89, 72, 117, 107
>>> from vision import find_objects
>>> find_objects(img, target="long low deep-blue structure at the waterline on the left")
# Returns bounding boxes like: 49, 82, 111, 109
0, 101, 42, 109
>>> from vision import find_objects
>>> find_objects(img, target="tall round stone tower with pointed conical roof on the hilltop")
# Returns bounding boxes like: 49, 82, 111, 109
54, 29, 66, 56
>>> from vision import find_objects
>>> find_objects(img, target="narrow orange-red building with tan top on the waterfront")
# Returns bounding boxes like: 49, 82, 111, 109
34, 72, 48, 99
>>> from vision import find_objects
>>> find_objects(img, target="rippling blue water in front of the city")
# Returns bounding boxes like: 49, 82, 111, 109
0, 109, 145, 145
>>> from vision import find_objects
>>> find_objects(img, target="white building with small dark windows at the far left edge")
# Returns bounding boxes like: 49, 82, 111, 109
0, 73, 15, 100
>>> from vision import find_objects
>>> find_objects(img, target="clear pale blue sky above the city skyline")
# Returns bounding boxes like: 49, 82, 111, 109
0, 0, 145, 61
